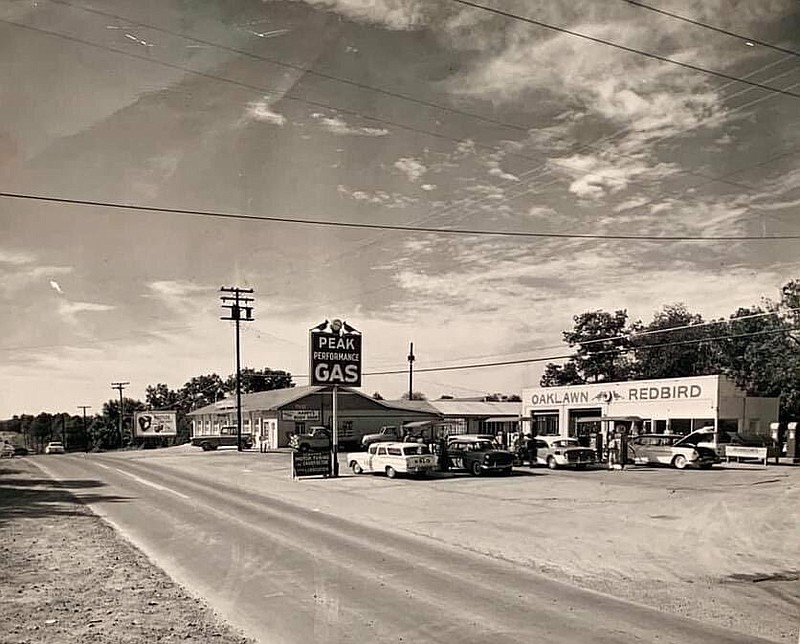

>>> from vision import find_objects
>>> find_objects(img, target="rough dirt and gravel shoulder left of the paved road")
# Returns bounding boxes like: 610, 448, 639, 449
0, 458, 253, 644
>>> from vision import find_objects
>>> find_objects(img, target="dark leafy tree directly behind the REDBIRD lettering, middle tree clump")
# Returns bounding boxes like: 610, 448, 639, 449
630, 304, 724, 379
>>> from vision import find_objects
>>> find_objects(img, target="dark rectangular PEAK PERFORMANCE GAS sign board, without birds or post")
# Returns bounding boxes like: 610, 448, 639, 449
309, 331, 361, 387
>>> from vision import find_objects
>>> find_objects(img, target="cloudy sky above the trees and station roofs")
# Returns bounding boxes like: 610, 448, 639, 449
0, 0, 800, 418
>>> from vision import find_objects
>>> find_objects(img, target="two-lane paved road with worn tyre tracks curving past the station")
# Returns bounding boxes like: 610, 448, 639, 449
33, 455, 767, 644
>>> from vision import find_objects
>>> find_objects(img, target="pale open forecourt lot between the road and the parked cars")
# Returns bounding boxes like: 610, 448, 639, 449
26, 447, 800, 644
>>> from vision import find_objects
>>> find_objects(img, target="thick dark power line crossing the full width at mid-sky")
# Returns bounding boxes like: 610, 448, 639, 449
0, 191, 800, 242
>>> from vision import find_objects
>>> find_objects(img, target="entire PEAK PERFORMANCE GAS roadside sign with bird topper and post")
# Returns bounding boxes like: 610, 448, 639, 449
308, 319, 361, 477
